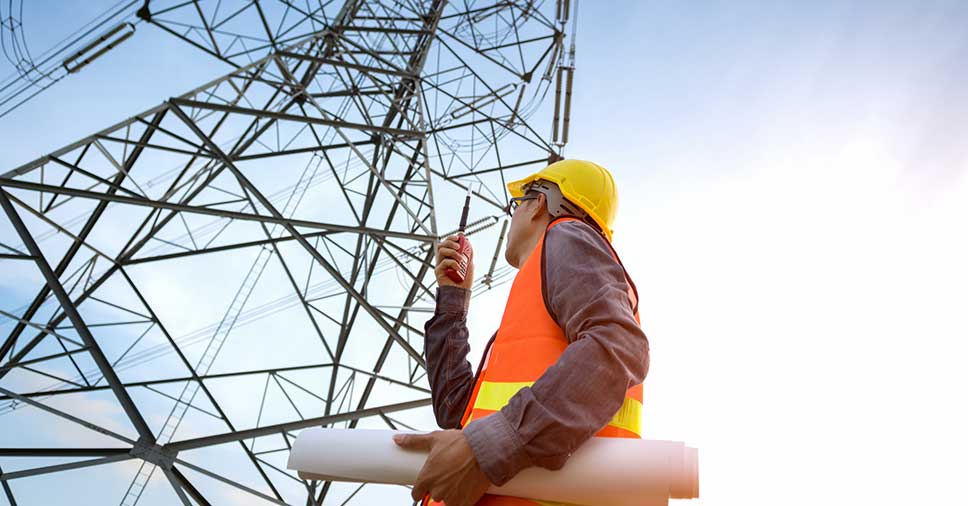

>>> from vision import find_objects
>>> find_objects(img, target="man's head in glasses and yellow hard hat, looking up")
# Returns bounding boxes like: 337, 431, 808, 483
504, 160, 618, 268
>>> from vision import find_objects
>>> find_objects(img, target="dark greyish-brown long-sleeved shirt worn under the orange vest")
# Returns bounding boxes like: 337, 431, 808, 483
424, 221, 649, 485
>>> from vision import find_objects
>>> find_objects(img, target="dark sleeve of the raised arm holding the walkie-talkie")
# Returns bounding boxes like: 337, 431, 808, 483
424, 286, 474, 429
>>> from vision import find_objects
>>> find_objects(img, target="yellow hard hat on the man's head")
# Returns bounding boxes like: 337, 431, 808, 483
508, 160, 618, 242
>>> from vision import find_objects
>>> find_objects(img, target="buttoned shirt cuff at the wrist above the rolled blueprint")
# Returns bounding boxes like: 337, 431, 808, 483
463, 411, 532, 486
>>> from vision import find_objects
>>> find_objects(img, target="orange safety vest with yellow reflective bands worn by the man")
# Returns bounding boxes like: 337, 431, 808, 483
423, 217, 642, 506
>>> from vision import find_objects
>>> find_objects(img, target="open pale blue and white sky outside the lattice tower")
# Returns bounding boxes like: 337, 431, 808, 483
0, 0, 968, 505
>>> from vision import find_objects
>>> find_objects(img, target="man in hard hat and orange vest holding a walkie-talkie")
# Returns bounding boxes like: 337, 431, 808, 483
395, 160, 649, 506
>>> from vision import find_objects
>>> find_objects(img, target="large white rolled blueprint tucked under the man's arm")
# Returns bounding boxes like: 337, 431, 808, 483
288, 429, 699, 506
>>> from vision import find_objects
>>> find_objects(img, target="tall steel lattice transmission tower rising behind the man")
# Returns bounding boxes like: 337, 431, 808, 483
0, 0, 574, 505
